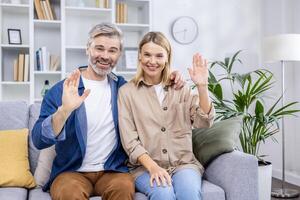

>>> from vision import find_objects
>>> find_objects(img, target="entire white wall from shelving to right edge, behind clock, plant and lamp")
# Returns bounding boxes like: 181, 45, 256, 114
152, 0, 300, 185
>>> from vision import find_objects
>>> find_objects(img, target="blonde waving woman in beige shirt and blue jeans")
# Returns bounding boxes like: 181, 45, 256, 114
118, 32, 214, 200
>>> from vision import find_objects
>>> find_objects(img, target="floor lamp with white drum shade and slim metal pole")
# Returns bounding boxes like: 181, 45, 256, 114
263, 34, 300, 198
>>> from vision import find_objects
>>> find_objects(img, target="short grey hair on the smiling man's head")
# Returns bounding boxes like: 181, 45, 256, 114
87, 23, 123, 50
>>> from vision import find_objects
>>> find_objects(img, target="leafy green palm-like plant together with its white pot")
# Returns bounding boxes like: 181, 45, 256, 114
204, 51, 299, 200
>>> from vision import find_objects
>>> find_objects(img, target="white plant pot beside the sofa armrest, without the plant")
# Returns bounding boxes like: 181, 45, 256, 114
258, 161, 272, 200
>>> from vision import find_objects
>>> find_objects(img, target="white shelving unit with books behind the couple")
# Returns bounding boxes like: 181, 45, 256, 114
0, 0, 151, 103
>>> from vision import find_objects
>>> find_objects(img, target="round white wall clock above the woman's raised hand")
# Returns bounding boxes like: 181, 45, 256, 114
171, 16, 198, 44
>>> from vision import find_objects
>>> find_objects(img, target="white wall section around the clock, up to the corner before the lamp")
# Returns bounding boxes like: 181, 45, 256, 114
152, 0, 261, 75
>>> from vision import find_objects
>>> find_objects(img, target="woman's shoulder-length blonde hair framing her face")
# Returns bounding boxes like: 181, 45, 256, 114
133, 32, 172, 85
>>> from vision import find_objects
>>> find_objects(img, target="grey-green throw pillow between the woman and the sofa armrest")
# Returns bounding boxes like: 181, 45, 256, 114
193, 117, 242, 167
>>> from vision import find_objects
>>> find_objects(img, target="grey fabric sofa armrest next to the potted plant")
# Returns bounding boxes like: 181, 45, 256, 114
204, 151, 258, 200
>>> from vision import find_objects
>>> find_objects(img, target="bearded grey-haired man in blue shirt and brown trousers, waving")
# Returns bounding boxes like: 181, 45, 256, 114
32, 23, 182, 200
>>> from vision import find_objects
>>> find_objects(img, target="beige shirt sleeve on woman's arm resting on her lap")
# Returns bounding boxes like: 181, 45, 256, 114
118, 88, 148, 165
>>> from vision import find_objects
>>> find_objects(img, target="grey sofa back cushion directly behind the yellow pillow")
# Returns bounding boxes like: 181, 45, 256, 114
0, 101, 29, 130
